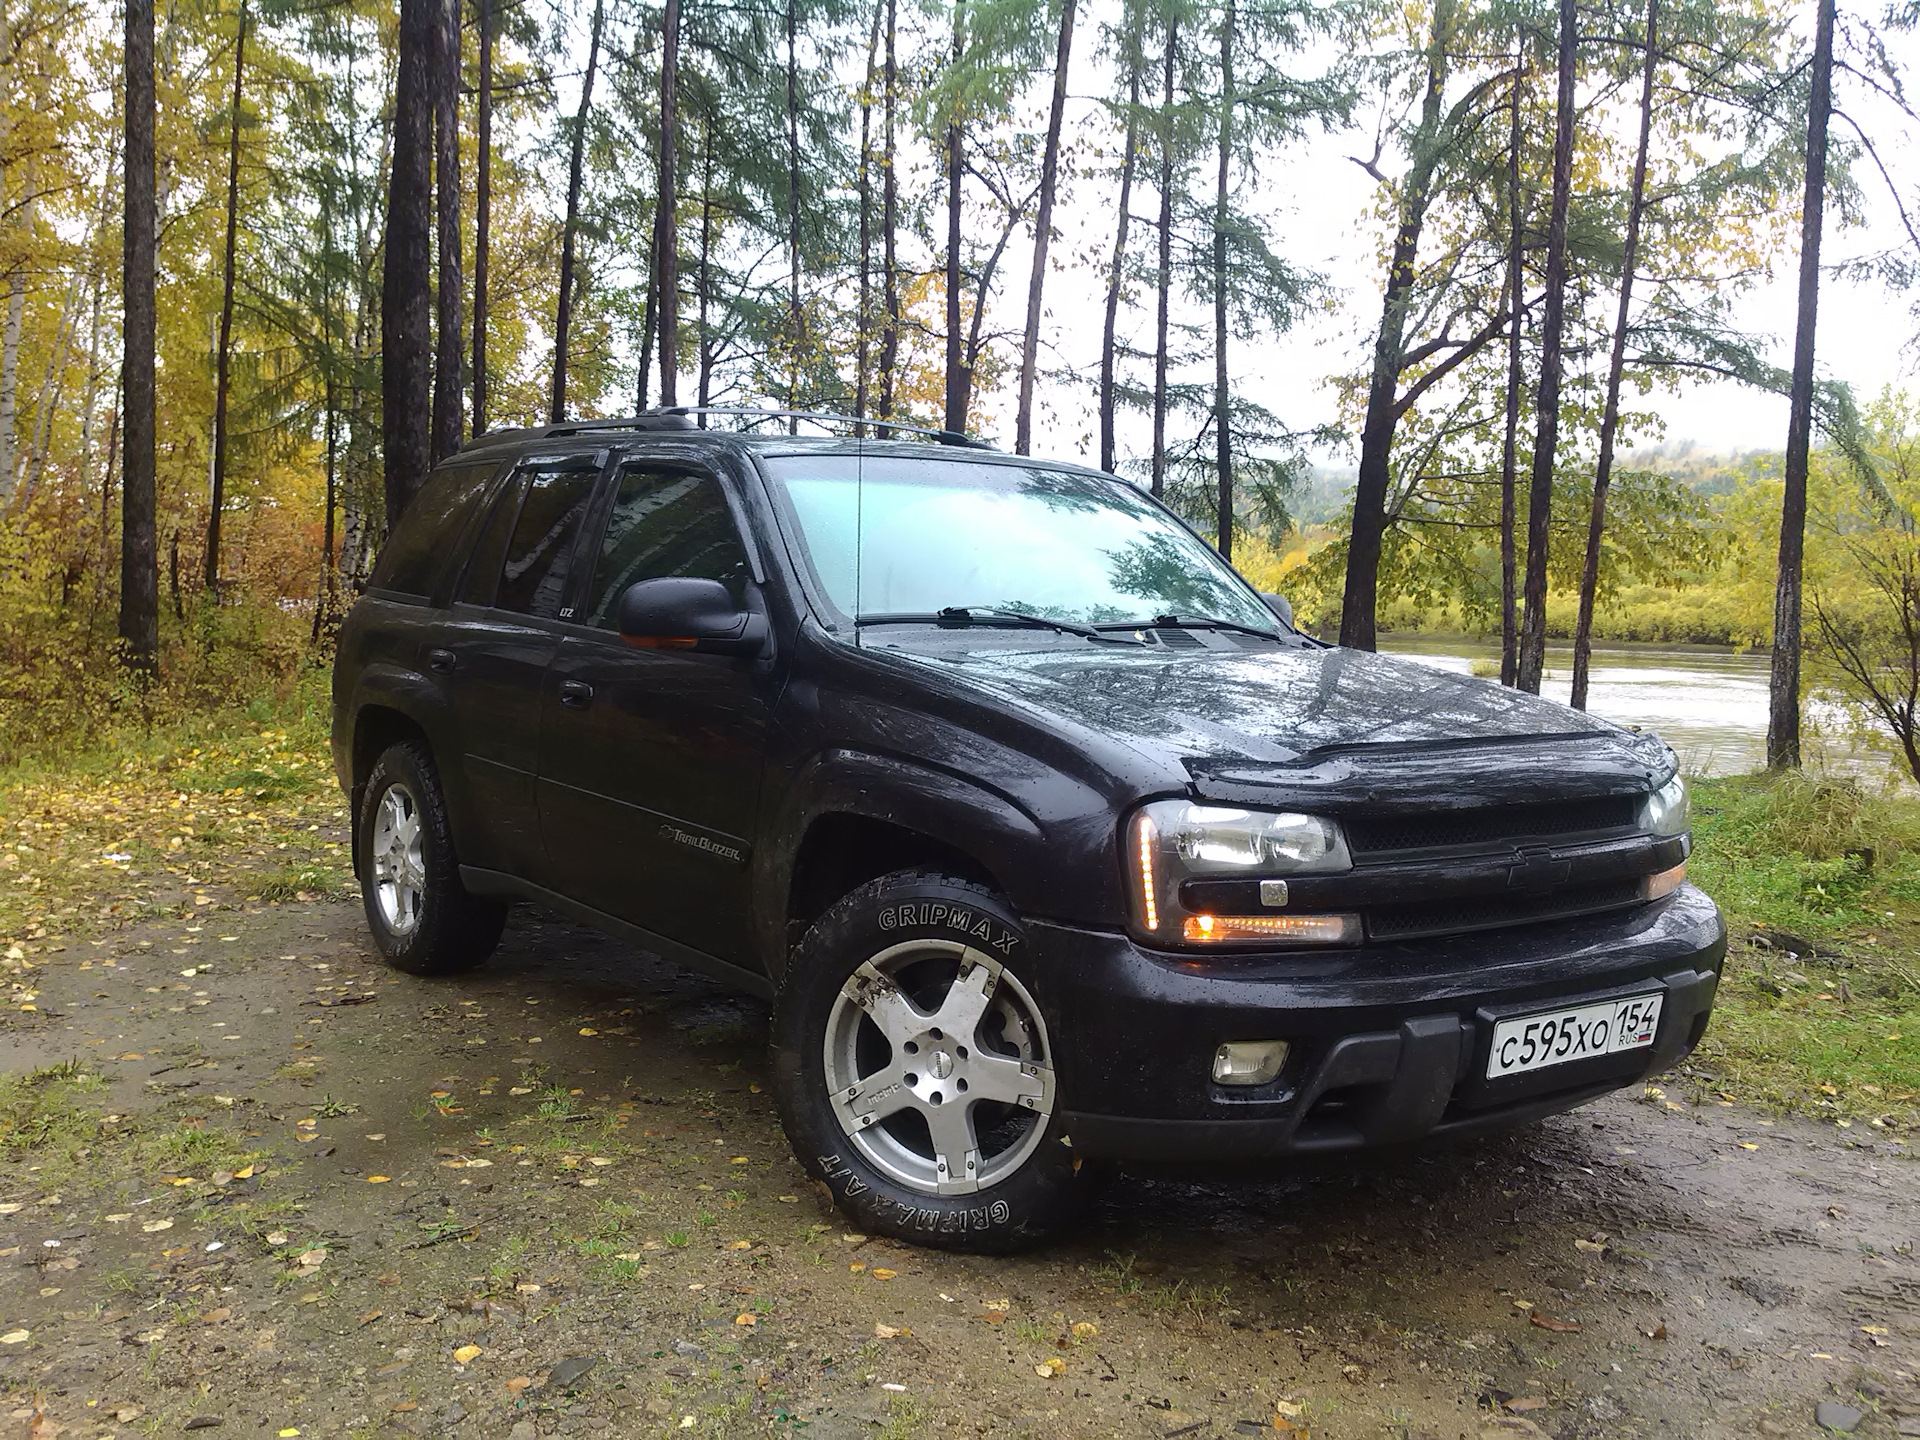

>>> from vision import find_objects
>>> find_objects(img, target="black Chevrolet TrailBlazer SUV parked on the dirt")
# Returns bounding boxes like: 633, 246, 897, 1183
332, 413, 1726, 1250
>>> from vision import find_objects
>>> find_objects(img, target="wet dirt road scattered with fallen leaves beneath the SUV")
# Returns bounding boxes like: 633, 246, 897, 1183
0, 891, 1920, 1440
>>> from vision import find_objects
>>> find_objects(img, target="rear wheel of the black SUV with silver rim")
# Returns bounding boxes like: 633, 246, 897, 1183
355, 741, 507, 975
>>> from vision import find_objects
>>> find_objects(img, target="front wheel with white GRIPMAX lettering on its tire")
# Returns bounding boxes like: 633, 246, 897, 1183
772, 870, 1079, 1254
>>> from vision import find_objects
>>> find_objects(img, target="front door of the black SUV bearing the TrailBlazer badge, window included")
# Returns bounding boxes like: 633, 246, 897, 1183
540, 461, 783, 962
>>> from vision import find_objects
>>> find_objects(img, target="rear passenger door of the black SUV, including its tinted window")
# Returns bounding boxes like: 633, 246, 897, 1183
437, 451, 605, 885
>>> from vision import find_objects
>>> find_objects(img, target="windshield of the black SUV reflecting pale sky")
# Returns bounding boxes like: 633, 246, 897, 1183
762, 455, 1279, 632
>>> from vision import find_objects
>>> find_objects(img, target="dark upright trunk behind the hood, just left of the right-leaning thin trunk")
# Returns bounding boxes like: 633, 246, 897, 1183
1517, 0, 1580, 695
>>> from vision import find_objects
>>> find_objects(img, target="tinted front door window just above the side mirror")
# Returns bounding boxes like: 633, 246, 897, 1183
582, 465, 749, 630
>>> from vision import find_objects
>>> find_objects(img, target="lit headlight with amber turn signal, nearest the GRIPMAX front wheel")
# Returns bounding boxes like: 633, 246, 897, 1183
1127, 801, 1359, 948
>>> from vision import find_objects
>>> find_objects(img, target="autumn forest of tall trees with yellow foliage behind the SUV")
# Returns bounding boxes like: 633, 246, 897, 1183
11, 0, 1920, 774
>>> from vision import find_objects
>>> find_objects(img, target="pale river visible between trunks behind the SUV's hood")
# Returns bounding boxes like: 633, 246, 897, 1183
1380, 634, 1891, 780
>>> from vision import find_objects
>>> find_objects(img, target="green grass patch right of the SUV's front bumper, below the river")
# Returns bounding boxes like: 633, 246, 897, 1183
1688, 774, 1920, 1131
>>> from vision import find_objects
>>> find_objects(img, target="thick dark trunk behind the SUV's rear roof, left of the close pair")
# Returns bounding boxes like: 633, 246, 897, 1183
380, 0, 440, 530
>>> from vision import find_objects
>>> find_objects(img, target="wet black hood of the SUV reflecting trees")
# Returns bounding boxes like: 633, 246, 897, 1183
890, 645, 1674, 803
